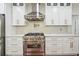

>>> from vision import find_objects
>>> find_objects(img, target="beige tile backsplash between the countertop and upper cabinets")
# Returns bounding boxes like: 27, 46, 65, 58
16, 21, 72, 34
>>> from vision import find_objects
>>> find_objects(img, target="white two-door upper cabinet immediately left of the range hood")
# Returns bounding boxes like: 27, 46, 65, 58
12, 3, 25, 26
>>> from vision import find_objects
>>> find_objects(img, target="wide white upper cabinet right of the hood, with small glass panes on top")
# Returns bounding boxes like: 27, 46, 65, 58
45, 3, 72, 25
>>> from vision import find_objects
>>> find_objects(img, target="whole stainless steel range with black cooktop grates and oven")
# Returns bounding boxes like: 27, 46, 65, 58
23, 33, 45, 56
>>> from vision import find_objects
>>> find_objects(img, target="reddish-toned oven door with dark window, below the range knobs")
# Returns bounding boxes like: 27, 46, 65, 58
24, 43, 44, 56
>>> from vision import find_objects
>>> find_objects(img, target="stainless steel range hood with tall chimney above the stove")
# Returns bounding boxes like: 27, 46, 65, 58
24, 3, 44, 21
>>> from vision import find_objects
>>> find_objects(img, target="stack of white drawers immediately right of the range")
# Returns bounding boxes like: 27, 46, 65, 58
45, 37, 57, 55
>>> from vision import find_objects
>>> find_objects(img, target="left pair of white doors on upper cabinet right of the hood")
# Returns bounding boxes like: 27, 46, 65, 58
45, 4, 59, 25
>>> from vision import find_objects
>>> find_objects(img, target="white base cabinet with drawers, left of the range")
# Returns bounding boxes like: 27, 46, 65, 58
6, 36, 23, 56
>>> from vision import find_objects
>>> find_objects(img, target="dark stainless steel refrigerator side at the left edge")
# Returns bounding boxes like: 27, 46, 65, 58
0, 14, 5, 55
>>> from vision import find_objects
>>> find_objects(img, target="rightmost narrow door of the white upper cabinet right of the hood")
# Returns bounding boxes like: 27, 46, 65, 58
65, 4, 72, 25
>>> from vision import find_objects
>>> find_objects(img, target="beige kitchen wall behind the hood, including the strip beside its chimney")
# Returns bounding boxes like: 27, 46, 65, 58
16, 4, 72, 34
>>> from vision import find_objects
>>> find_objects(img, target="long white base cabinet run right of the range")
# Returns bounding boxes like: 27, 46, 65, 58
45, 37, 78, 55
